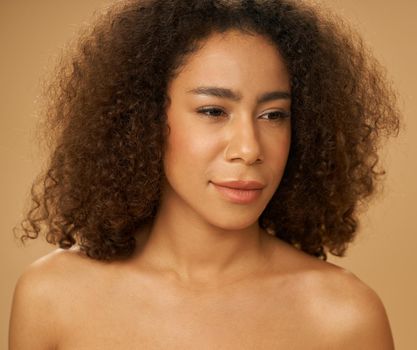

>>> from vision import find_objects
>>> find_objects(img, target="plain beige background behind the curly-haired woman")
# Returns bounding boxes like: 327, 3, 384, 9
0, 0, 417, 350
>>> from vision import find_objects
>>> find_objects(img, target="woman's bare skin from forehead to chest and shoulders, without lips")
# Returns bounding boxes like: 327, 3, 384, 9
9, 31, 394, 350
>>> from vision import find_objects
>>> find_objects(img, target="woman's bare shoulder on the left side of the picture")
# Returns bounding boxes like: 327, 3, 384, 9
9, 249, 95, 350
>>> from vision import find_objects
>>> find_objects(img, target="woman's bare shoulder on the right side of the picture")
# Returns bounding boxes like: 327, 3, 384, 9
270, 241, 394, 350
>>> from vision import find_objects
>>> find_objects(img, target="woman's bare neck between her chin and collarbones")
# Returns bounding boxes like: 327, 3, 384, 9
135, 200, 269, 286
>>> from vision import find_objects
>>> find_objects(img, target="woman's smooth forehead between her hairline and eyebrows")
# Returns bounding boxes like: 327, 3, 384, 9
168, 31, 289, 93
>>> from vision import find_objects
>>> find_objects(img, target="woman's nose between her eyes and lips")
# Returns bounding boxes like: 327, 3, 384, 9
225, 116, 263, 165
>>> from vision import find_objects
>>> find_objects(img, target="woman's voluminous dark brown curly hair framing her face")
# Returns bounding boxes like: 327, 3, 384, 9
14, 0, 400, 260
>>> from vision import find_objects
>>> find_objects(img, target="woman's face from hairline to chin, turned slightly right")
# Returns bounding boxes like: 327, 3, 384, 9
162, 31, 291, 230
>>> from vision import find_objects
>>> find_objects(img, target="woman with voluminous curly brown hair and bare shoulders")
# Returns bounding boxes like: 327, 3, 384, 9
10, 0, 399, 350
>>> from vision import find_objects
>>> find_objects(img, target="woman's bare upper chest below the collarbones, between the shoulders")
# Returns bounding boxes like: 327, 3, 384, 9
59, 282, 324, 350
